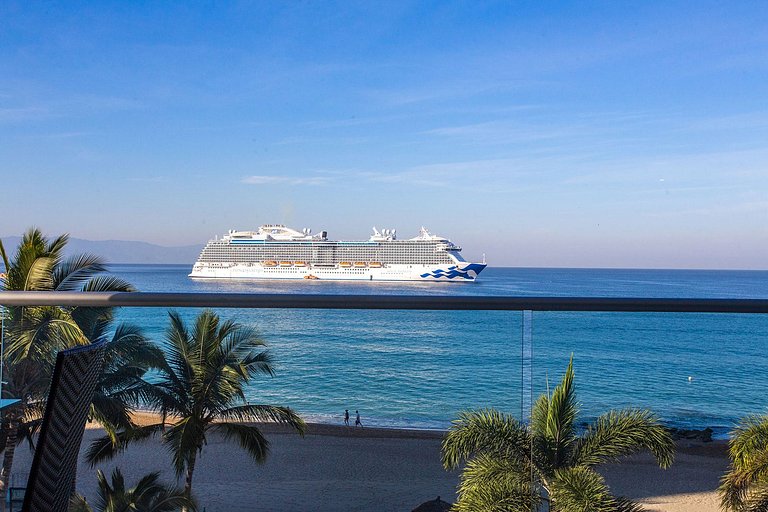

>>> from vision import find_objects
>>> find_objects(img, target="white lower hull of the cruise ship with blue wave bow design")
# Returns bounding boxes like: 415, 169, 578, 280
189, 262, 486, 282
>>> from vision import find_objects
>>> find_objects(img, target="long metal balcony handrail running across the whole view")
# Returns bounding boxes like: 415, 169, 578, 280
0, 291, 768, 313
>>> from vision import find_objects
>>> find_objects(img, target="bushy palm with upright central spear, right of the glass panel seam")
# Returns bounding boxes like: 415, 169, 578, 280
443, 358, 674, 512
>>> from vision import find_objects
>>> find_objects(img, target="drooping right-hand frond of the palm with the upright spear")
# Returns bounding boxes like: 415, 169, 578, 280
571, 409, 675, 468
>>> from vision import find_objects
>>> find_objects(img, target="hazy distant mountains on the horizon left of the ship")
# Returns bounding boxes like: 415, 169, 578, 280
2, 236, 203, 265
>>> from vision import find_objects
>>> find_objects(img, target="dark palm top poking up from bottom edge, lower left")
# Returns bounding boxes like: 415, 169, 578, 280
69, 468, 197, 512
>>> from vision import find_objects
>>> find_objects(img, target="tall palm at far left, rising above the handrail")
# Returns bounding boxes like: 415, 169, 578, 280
0, 228, 133, 491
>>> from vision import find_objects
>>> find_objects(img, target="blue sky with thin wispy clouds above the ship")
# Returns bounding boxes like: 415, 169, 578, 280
0, 0, 768, 269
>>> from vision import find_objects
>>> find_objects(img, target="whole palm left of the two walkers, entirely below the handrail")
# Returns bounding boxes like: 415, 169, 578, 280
87, 311, 305, 495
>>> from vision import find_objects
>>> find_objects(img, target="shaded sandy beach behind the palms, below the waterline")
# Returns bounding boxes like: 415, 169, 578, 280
14, 417, 727, 512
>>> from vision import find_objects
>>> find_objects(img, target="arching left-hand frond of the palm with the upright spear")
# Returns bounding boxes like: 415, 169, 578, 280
442, 409, 531, 469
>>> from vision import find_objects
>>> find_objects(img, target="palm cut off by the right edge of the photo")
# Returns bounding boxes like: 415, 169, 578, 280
719, 416, 768, 512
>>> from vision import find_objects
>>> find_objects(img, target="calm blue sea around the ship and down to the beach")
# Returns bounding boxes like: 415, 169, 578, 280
112, 265, 768, 434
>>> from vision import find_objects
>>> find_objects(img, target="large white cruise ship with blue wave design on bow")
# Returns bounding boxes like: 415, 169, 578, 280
189, 224, 486, 282
